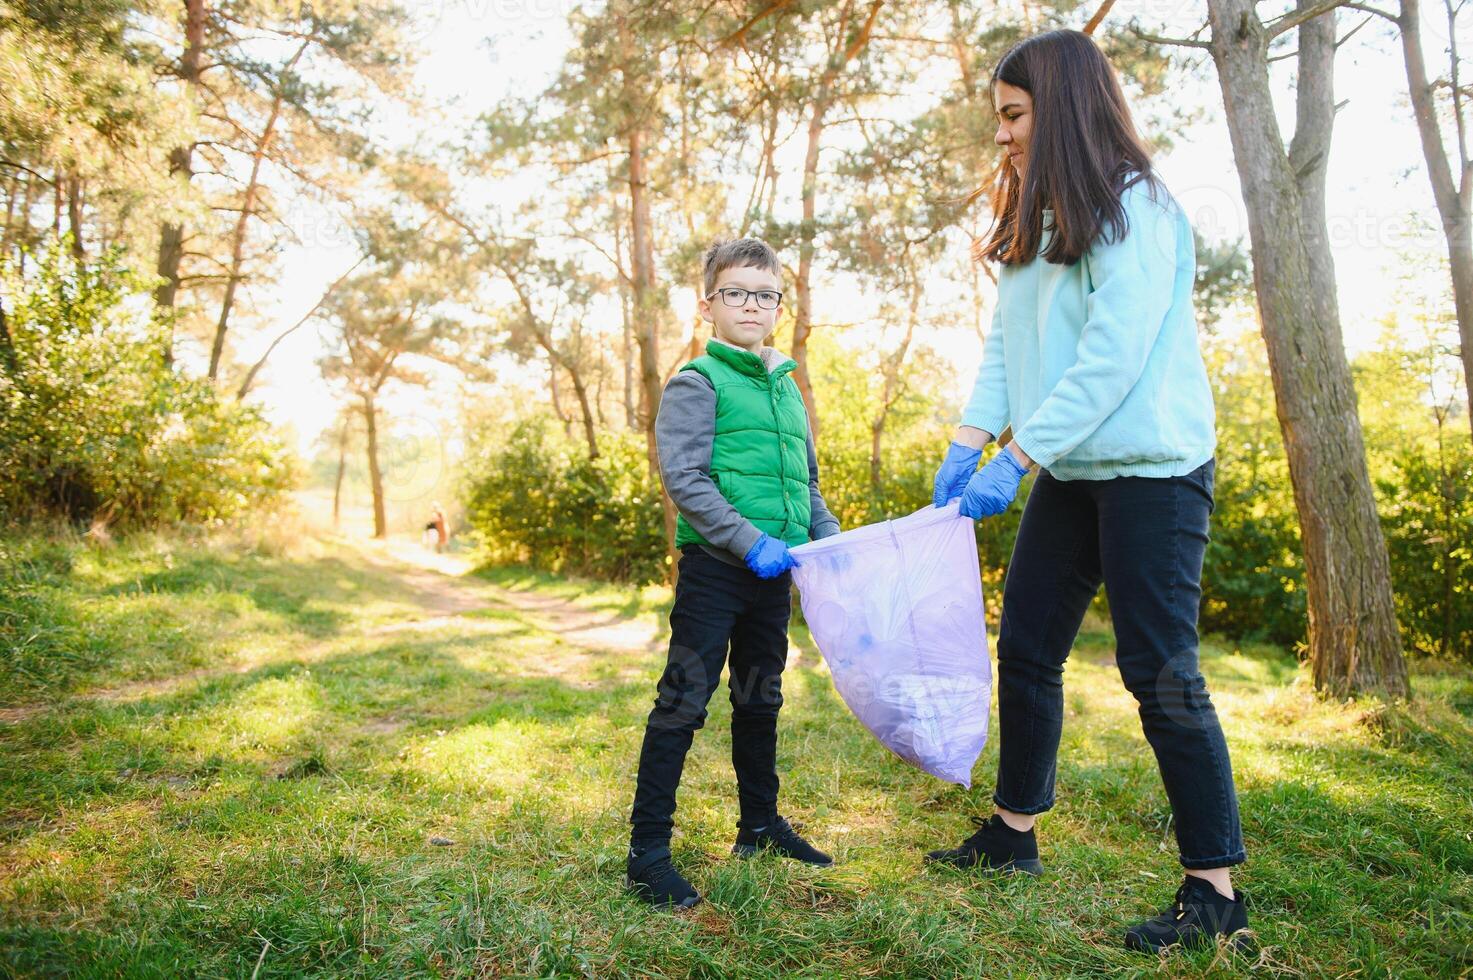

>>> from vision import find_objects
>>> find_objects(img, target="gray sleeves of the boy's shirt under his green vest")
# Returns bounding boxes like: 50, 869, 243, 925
654, 359, 840, 564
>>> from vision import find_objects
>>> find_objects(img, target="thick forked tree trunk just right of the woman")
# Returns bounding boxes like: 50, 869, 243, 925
1208, 0, 1408, 697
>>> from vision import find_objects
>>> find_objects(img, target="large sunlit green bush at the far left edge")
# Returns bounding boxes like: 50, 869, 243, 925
0, 246, 295, 526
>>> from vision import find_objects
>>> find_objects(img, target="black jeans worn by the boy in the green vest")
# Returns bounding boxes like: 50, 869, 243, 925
629, 545, 792, 843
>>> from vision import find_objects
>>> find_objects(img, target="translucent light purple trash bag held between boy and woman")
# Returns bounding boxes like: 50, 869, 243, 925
792, 501, 993, 787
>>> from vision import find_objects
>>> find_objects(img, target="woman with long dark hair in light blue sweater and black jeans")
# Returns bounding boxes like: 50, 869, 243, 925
928, 31, 1248, 951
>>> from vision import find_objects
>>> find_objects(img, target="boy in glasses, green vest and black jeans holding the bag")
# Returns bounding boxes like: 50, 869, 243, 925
625, 232, 838, 908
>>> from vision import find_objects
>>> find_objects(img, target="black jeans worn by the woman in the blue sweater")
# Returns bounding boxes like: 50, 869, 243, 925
993, 460, 1246, 869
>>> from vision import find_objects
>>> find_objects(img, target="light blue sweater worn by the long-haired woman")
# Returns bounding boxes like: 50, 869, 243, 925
962, 181, 1217, 480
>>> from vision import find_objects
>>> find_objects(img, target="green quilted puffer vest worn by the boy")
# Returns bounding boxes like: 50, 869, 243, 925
675, 340, 813, 548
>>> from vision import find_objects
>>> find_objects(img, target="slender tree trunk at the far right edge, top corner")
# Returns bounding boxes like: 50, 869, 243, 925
1395, 0, 1473, 439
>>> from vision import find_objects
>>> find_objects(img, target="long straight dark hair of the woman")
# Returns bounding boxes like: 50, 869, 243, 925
972, 31, 1156, 265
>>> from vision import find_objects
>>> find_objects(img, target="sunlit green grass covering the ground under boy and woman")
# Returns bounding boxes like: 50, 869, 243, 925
0, 538, 1473, 977
